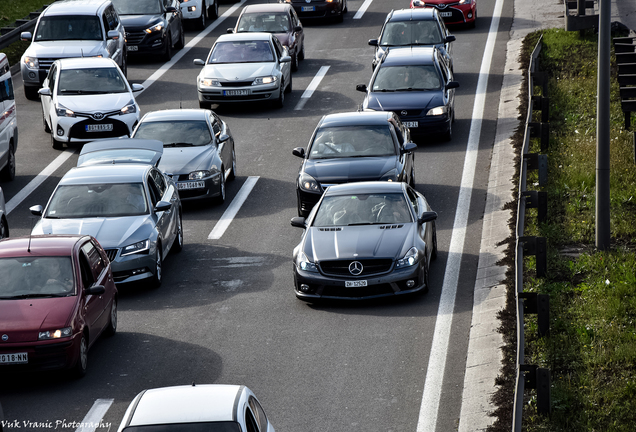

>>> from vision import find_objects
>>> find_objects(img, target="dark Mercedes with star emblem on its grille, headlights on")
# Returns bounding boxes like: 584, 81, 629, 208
291, 182, 437, 301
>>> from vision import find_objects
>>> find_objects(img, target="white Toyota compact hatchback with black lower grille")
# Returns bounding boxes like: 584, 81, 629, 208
38, 58, 144, 149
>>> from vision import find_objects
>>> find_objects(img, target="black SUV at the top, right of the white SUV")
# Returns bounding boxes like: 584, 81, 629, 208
112, 0, 185, 61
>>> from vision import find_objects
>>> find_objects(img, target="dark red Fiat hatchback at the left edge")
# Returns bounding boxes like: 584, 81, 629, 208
0, 235, 117, 377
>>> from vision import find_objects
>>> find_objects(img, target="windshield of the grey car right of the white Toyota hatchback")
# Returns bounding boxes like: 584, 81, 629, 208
133, 120, 212, 147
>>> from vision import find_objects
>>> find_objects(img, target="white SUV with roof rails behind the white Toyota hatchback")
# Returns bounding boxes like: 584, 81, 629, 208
20, 0, 127, 100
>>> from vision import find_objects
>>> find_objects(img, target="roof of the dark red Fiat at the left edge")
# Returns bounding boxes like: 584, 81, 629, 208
0, 235, 90, 258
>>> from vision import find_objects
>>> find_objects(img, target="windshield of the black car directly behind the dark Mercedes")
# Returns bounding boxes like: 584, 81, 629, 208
309, 122, 396, 159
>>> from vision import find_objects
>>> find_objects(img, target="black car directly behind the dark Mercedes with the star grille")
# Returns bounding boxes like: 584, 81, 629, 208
292, 111, 417, 216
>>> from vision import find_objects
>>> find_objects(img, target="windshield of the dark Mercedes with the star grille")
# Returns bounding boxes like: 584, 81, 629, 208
312, 193, 412, 227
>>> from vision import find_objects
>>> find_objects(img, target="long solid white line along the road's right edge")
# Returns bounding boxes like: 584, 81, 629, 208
417, 0, 503, 432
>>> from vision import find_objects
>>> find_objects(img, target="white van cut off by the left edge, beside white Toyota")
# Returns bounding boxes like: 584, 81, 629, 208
0, 53, 18, 181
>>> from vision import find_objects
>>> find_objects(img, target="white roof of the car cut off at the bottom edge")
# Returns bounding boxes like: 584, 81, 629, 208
128, 384, 244, 426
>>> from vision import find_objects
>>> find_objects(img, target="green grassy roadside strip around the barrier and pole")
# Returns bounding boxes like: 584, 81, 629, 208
491, 29, 636, 432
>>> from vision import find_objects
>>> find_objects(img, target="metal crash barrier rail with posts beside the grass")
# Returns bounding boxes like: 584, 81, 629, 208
512, 36, 551, 432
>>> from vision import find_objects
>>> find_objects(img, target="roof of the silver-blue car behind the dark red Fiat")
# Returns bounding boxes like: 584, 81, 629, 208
60, 164, 150, 185
